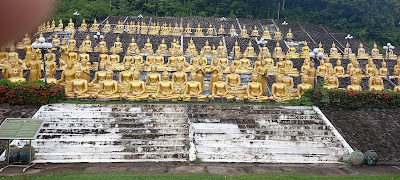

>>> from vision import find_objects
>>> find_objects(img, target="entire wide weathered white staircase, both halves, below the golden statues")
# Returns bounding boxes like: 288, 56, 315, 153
3, 104, 352, 163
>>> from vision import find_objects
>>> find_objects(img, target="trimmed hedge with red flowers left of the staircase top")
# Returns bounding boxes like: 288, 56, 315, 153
0, 79, 66, 105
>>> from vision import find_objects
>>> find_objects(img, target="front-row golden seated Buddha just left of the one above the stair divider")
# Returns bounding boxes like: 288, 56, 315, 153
154, 71, 180, 101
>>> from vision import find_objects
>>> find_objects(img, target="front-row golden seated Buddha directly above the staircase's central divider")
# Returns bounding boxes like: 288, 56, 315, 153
182, 72, 207, 101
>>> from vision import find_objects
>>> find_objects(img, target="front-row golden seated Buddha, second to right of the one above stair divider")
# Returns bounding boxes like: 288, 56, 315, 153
244, 73, 269, 102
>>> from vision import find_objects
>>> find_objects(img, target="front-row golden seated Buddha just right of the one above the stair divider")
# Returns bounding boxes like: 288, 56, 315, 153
208, 73, 235, 100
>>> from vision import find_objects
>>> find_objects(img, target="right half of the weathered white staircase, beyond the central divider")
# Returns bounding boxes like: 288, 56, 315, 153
189, 106, 352, 163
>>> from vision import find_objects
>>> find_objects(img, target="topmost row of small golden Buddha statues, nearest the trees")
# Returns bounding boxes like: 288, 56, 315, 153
38, 19, 293, 40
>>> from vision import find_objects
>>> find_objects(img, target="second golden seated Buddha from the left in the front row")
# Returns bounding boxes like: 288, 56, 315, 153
95, 71, 121, 100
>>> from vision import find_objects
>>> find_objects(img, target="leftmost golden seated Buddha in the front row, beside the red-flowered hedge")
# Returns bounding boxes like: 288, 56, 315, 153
65, 70, 91, 99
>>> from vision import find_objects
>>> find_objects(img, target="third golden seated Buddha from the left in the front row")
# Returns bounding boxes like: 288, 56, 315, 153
125, 70, 149, 101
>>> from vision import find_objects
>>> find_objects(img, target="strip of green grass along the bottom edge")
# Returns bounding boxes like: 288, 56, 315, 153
0, 172, 400, 180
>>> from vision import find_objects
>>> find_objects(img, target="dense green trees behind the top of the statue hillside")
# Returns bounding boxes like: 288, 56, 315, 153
54, 0, 400, 46
